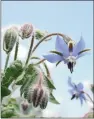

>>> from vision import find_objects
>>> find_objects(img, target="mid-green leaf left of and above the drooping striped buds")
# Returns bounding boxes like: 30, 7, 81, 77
16, 64, 38, 95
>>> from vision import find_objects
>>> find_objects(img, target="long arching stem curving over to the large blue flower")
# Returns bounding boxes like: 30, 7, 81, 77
32, 33, 72, 53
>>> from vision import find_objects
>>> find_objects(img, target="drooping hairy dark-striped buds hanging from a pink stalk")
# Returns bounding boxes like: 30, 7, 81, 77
28, 73, 49, 109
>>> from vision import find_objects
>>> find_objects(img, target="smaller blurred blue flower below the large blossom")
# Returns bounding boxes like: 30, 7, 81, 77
68, 77, 86, 105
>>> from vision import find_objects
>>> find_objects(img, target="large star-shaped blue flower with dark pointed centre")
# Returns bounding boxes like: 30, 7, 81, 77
43, 36, 90, 73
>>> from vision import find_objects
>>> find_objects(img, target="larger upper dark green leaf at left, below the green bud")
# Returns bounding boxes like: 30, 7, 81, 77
1, 60, 23, 87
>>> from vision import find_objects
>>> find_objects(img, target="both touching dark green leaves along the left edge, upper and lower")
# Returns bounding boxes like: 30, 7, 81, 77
1, 60, 23, 98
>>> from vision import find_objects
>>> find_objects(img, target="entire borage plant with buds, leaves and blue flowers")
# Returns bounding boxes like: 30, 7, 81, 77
1, 24, 93, 118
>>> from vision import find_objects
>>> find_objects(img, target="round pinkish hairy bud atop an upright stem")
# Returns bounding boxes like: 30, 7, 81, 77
19, 24, 33, 39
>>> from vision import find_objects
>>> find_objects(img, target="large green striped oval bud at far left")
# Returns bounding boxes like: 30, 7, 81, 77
3, 27, 18, 53
